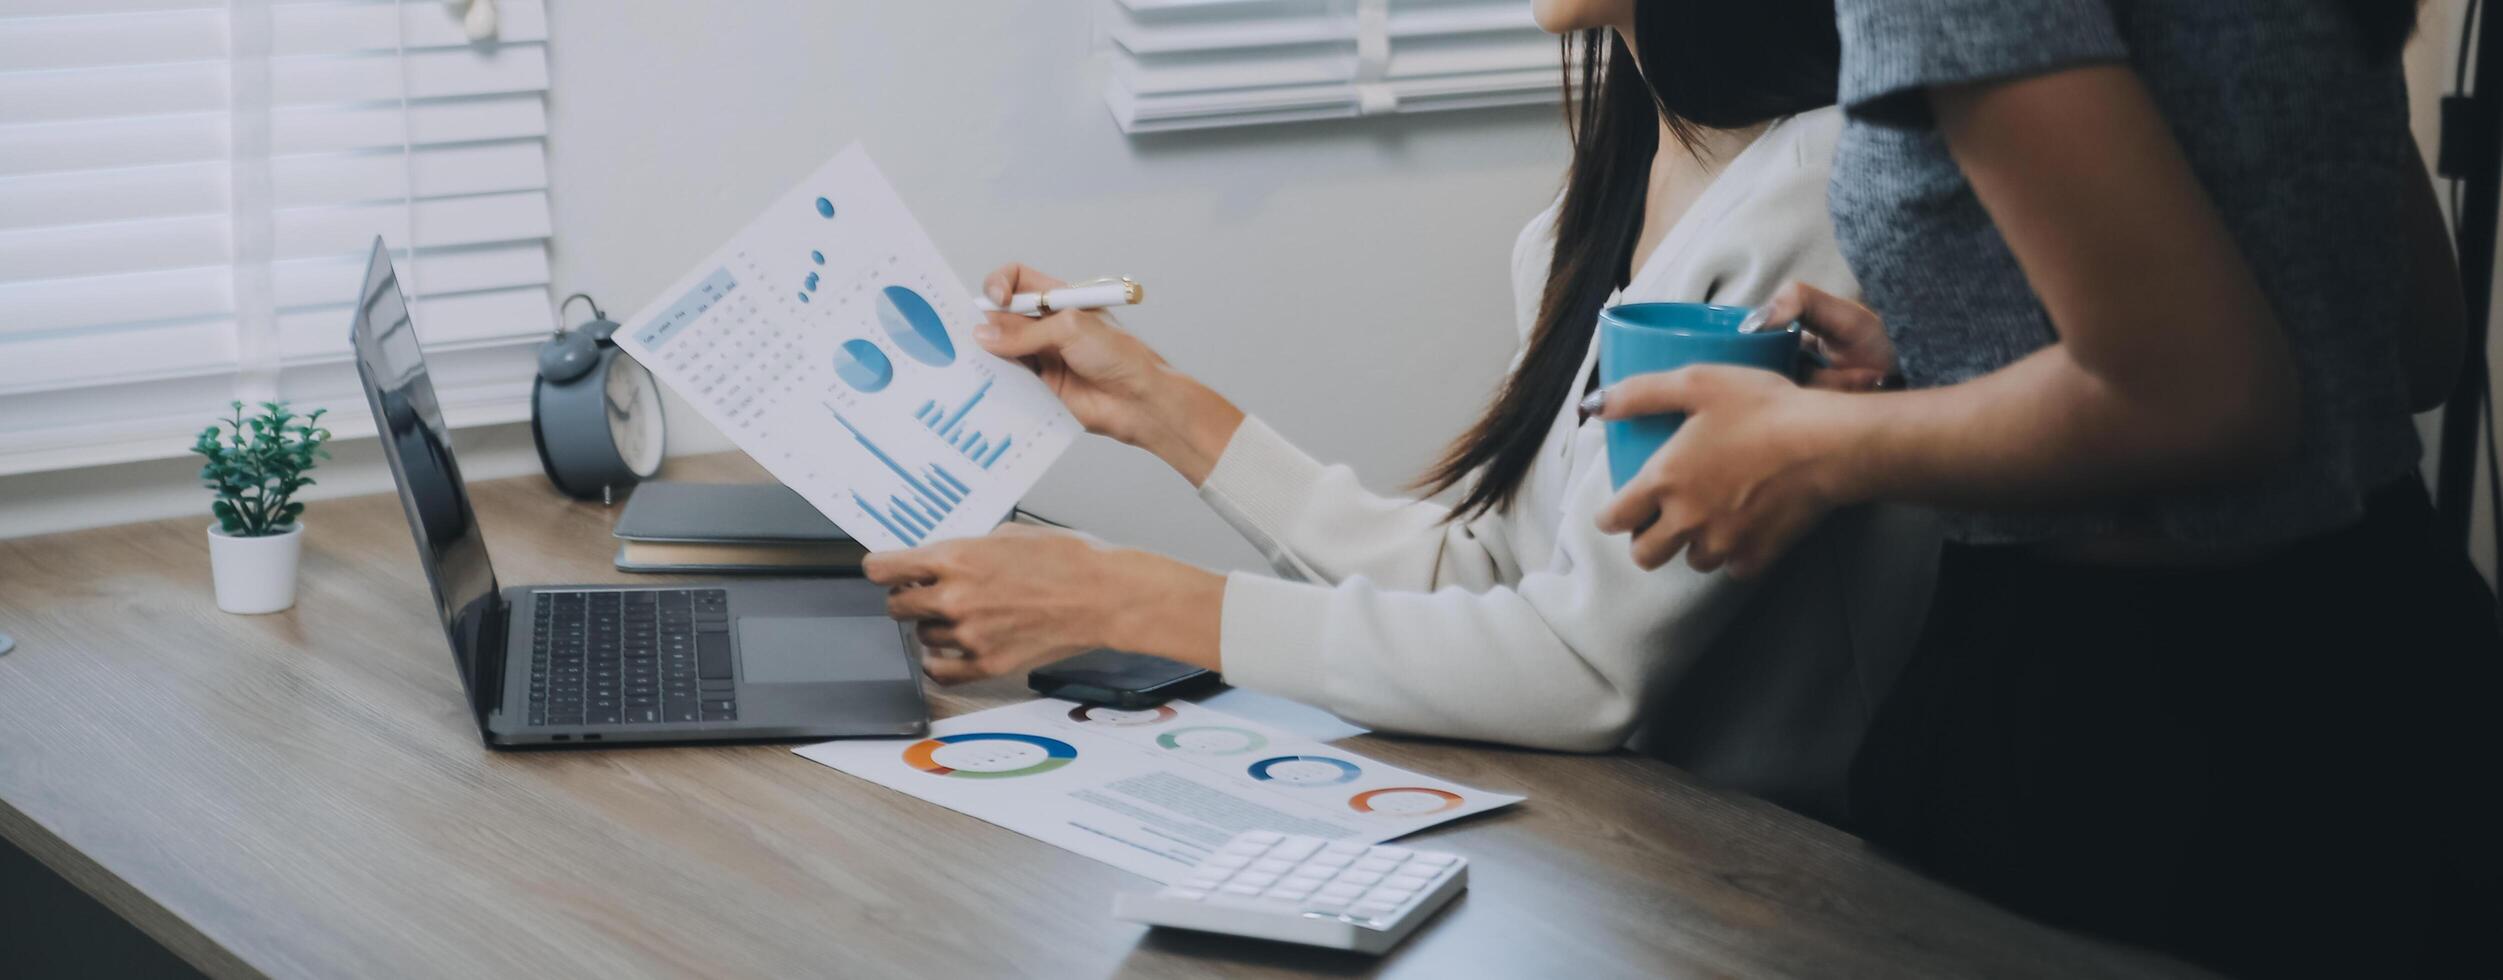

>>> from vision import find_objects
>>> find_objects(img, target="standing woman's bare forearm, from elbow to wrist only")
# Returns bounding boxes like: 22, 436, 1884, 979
1827, 345, 2285, 510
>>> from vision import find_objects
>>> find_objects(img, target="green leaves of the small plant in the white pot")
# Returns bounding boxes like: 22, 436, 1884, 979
190, 403, 330, 538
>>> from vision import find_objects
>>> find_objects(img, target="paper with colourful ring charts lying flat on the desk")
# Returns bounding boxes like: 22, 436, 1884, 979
796, 698, 1522, 883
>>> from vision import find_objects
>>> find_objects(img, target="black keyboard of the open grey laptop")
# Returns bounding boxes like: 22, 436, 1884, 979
531, 590, 738, 725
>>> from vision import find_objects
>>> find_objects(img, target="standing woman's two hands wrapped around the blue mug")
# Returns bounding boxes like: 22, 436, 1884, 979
1584, 285, 1895, 578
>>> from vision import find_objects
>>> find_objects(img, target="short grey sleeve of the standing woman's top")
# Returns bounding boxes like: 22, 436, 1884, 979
1840, 0, 2130, 125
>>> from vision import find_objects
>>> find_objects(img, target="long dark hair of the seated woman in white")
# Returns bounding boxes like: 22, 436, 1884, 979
1417, 0, 1842, 520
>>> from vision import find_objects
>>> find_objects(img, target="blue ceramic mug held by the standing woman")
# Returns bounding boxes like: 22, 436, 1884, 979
1599, 303, 1800, 490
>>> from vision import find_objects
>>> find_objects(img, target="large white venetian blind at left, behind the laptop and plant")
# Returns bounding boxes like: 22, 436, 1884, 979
0, 0, 551, 473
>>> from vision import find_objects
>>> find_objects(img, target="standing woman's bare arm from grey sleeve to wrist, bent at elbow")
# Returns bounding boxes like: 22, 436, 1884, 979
1837, 65, 2300, 510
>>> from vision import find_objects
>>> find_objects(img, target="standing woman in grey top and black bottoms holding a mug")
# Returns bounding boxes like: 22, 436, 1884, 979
1599, 0, 2503, 975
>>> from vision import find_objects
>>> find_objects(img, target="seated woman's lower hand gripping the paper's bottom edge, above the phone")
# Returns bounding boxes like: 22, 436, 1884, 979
861, 525, 1226, 685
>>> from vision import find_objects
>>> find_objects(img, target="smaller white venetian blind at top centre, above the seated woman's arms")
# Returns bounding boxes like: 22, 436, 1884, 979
1101, 0, 1559, 133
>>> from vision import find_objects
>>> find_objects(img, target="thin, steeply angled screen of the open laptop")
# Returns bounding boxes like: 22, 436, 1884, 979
348, 238, 503, 715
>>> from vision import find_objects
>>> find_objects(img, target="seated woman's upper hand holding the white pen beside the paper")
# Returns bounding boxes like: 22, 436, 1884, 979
974, 265, 1244, 485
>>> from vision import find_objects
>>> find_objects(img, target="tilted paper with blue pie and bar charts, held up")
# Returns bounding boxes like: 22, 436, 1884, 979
616, 145, 1079, 550
